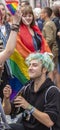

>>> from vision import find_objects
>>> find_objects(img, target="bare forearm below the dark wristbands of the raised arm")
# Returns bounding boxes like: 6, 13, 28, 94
0, 31, 17, 64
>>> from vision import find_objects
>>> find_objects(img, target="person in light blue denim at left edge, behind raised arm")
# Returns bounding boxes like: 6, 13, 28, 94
0, 3, 11, 47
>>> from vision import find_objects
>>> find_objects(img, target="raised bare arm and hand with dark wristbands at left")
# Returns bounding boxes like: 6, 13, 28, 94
0, 11, 21, 64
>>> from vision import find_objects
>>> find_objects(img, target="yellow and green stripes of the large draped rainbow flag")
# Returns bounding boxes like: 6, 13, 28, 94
10, 49, 29, 84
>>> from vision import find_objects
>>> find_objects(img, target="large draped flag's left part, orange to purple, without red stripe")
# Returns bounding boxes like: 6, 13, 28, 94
9, 27, 31, 100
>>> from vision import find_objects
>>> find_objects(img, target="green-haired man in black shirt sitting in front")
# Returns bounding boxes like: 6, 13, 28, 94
3, 52, 60, 130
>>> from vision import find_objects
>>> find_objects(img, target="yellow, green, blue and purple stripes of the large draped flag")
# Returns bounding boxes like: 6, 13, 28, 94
10, 48, 29, 99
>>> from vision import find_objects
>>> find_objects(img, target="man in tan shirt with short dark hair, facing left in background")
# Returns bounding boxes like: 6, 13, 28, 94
41, 7, 58, 85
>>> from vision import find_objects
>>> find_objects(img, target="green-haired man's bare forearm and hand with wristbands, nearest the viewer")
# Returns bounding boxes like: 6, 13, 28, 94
14, 96, 54, 127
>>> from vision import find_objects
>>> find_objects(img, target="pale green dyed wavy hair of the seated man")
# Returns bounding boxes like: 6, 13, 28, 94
26, 52, 54, 72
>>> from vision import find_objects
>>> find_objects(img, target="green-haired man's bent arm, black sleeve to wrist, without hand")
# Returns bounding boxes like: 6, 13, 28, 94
32, 88, 60, 127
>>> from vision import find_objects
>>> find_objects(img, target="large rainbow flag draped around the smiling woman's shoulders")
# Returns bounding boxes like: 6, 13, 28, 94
10, 25, 50, 99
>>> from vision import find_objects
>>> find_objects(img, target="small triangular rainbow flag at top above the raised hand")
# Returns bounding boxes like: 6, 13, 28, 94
5, 0, 19, 15
